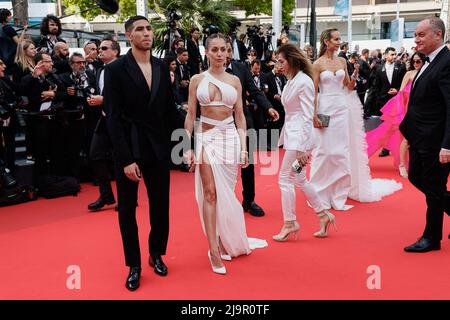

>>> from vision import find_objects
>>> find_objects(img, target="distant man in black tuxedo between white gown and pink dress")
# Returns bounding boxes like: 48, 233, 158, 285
372, 47, 406, 157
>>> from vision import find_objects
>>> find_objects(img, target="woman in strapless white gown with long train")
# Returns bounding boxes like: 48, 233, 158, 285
311, 28, 402, 210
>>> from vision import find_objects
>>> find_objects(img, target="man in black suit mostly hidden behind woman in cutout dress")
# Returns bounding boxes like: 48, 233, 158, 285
226, 41, 280, 217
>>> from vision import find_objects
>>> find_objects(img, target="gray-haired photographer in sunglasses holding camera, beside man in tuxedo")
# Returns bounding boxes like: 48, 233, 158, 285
60, 52, 96, 178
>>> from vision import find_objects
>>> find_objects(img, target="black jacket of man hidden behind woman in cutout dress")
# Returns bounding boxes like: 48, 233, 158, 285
231, 61, 272, 129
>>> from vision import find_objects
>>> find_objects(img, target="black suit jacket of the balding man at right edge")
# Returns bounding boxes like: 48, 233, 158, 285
400, 47, 450, 150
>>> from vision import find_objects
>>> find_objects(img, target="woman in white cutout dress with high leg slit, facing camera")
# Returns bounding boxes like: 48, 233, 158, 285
185, 34, 267, 274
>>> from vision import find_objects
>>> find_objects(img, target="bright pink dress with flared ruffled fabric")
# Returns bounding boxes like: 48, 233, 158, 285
366, 81, 412, 167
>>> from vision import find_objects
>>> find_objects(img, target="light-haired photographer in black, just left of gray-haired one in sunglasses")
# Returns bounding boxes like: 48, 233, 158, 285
21, 52, 67, 178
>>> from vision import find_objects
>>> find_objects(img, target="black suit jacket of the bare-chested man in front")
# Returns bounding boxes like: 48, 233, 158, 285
103, 49, 178, 167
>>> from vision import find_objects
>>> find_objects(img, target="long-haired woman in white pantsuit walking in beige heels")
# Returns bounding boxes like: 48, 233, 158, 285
273, 44, 334, 241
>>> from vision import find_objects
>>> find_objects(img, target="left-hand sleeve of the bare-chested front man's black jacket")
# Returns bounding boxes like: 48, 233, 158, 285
103, 66, 135, 168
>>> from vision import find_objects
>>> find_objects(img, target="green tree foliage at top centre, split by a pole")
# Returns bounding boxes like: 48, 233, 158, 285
234, 0, 295, 24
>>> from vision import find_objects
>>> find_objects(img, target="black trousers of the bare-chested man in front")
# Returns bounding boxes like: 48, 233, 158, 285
115, 152, 170, 267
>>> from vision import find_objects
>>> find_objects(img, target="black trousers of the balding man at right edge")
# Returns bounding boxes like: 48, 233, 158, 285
408, 148, 450, 242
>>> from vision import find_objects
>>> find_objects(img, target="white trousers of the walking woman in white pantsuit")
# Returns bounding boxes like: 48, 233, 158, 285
278, 150, 325, 221
